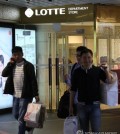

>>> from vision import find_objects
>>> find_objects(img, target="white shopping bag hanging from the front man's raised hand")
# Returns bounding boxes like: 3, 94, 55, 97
101, 72, 118, 106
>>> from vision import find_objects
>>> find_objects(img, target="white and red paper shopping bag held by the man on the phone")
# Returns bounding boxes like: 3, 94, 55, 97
24, 103, 46, 128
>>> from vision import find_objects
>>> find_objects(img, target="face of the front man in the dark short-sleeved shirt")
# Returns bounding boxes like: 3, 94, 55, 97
81, 53, 93, 67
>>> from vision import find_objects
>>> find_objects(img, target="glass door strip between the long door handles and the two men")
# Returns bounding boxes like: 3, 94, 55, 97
56, 34, 68, 109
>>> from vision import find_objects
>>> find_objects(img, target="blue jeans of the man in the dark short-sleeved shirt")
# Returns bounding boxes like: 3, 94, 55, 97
77, 103, 101, 133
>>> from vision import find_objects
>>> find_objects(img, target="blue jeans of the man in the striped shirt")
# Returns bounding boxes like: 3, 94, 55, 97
13, 97, 32, 134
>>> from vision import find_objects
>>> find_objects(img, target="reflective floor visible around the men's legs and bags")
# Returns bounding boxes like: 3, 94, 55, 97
0, 108, 120, 134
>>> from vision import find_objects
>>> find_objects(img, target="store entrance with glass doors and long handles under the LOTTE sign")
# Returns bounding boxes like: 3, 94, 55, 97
37, 22, 95, 111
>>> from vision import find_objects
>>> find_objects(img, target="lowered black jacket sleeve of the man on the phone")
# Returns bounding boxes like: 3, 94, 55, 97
31, 65, 38, 97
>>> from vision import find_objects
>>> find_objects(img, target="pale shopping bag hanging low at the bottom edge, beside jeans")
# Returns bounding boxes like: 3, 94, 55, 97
64, 116, 78, 134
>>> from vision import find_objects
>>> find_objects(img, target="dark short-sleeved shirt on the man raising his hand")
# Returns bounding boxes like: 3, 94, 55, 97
71, 66, 106, 102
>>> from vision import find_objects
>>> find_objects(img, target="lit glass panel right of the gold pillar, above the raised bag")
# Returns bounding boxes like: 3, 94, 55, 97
97, 23, 120, 69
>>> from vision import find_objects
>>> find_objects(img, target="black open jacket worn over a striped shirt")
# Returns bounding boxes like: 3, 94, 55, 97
2, 59, 38, 98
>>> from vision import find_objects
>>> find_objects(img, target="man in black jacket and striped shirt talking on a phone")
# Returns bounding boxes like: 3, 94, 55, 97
2, 46, 39, 134
